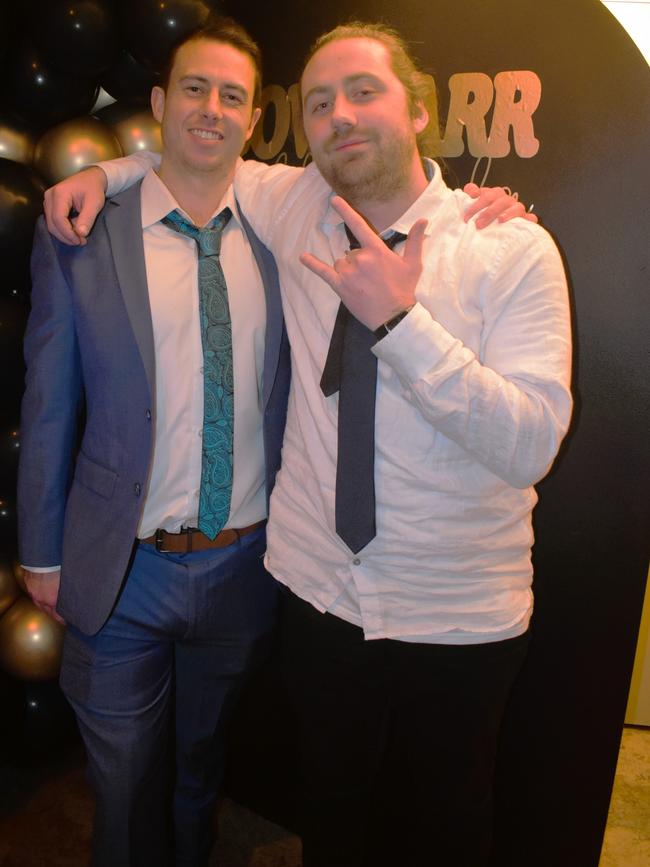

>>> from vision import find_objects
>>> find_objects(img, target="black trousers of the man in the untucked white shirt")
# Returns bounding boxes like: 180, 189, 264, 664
281, 593, 528, 867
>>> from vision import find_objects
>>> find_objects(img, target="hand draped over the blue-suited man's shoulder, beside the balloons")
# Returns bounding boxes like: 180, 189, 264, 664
44, 166, 106, 246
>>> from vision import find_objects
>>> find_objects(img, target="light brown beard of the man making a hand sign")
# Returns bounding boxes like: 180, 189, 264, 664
313, 130, 416, 205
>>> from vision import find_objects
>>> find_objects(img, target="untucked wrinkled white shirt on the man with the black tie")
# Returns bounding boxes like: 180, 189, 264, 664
98, 154, 571, 644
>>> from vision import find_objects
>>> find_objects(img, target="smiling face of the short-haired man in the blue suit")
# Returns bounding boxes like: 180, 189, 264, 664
151, 39, 260, 182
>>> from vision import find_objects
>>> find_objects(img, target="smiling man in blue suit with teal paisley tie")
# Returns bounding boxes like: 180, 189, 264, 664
19, 20, 289, 867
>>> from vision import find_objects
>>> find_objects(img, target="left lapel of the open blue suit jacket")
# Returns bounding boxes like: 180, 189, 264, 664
104, 183, 156, 395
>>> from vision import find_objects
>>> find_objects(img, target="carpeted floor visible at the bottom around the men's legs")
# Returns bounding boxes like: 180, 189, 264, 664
0, 728, 650, 867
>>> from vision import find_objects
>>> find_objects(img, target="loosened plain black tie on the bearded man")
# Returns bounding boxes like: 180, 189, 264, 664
320, 226, 406, 554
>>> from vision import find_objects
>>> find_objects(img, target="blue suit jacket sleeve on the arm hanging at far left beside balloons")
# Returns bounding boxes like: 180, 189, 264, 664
18, 218, 82, 567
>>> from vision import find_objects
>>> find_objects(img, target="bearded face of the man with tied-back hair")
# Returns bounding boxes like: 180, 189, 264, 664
301, 38, 428, 206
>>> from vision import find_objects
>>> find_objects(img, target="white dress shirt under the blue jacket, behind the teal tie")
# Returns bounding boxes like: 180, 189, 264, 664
138, 170, 266, 538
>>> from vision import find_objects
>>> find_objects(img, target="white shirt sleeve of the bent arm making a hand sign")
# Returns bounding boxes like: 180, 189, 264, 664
374, 227, 572, 488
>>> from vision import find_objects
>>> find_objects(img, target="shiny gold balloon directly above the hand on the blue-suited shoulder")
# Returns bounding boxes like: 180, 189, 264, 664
34, 117, 122, 184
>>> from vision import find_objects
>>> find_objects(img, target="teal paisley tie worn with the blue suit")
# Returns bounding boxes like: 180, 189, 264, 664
162, 208, 234, 539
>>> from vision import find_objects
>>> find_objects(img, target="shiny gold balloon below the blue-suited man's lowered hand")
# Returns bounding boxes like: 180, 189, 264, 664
0, 597, 64, 680
